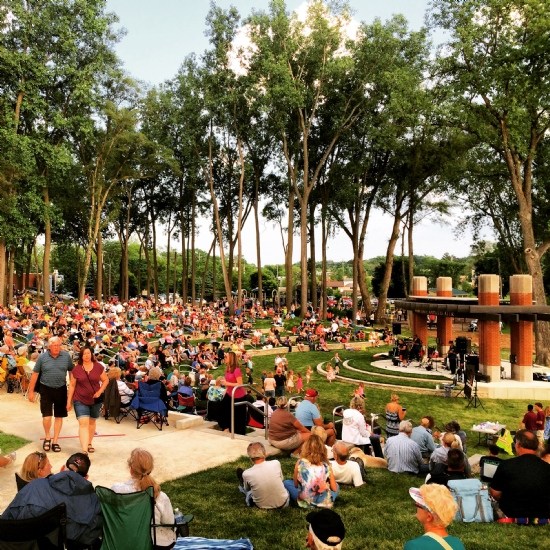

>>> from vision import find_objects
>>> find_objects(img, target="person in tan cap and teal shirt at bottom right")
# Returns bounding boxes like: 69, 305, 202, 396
403, 484, 464, 550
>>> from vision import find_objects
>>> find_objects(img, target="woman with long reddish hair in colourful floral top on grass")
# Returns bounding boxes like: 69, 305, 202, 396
283, 434, 339, 508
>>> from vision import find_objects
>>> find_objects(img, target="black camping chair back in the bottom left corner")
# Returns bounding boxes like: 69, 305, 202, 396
0, 503, 67, 550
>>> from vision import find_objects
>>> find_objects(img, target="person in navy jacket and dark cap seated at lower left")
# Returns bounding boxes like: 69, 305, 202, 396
2, 453, 103, 548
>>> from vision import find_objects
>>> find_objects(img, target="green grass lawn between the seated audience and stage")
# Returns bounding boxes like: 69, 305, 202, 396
0, 348, 550, 550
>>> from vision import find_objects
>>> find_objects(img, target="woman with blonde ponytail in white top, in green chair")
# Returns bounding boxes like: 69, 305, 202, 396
111, 448, 176, 550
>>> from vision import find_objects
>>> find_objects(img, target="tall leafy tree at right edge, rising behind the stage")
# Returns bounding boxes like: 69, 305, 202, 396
432, 0, 550, 364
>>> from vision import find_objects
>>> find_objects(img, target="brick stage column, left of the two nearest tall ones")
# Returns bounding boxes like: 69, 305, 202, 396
478, 275, 500, 382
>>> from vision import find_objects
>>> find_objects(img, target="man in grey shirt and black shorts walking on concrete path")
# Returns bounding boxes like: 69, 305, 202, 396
28, 336, 74, 453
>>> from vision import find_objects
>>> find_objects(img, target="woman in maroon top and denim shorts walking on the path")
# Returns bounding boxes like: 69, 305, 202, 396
67, 346, 109, 454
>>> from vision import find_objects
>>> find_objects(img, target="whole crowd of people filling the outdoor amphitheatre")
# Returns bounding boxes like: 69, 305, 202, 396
0, 300, 550, 549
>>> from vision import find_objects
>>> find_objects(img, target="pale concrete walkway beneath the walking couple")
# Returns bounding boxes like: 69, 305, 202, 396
0, 389, 268, 512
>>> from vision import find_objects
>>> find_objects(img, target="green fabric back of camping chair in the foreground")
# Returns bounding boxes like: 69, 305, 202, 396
95, 486, 156, 550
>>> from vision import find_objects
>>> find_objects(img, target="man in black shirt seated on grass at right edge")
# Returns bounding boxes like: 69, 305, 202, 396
489, 430, 550, 519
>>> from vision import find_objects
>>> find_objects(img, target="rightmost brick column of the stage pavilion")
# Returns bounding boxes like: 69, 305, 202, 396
510, 275, 534, 382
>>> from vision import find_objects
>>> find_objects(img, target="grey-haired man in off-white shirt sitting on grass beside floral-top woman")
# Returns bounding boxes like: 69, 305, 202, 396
237, 442, 289, 510
